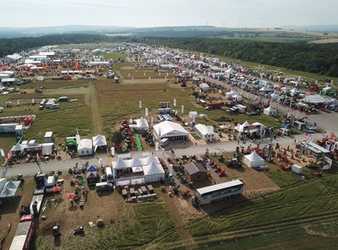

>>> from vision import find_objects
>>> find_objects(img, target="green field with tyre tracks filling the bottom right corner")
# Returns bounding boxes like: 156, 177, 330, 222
182, 174, 338, 249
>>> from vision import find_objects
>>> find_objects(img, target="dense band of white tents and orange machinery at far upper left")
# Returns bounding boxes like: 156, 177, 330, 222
0, 46, 125, 82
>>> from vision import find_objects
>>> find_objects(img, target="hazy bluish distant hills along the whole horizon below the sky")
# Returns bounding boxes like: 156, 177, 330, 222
0, 25, 330, 41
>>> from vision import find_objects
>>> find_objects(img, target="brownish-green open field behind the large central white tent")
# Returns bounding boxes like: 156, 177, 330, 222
96, 80, 198, 133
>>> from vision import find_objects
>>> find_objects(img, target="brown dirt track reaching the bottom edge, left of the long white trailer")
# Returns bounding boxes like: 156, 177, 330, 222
160, 193, 196, 249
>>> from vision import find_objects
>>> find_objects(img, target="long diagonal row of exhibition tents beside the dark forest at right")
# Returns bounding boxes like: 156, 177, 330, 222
129, 44, 338, 110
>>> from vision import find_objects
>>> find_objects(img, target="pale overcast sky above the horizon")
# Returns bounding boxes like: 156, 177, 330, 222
0, 0, 338, 27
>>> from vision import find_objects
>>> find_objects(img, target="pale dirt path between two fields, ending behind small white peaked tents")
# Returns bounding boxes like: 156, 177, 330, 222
86, 82, 103, 134
